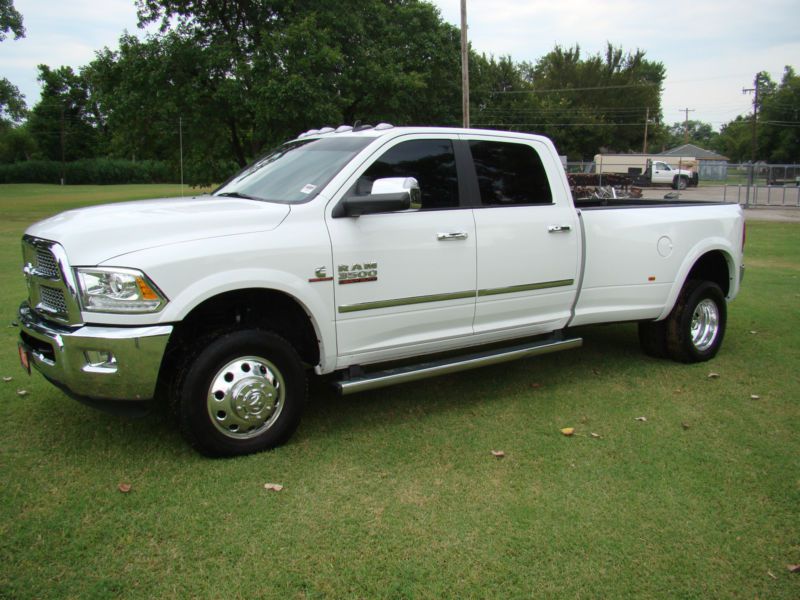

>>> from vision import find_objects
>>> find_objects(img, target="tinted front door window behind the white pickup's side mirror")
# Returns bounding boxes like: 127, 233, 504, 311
351, 140, 458, 210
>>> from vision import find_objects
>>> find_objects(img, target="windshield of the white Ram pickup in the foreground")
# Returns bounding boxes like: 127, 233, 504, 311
214, 137, 372, 204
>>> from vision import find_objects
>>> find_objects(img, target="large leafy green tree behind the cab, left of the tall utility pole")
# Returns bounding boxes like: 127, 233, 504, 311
81, 0, 461, 181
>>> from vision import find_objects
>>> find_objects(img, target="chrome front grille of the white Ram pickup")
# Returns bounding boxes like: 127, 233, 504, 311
22, 235, 81, 325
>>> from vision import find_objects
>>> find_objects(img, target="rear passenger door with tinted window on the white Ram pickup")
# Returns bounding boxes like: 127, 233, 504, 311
465, 135, 580, 336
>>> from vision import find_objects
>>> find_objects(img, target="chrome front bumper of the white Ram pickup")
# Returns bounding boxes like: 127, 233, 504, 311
19, 302, 172, 401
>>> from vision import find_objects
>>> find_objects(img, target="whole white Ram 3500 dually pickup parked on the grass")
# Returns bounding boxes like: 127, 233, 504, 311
19, 123, 745, 456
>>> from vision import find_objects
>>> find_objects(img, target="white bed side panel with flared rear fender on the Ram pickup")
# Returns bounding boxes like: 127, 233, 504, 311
571, 204, 743, 325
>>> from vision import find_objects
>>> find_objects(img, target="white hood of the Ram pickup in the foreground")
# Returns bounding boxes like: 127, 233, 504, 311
26, 196, 290, 265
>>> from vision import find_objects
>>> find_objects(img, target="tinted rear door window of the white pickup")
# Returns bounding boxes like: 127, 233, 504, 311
469, 140, 553, 206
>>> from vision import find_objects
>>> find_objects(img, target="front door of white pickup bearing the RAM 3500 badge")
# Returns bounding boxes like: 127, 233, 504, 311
327, 134, 476, 362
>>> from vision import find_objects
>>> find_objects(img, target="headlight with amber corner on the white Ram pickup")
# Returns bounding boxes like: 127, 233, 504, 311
75, 268, 168, 313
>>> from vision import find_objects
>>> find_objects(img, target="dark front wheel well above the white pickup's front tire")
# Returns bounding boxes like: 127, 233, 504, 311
168, 289, 319, 365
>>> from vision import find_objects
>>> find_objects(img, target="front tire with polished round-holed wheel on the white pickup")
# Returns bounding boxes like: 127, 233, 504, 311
177, 329, 307, 457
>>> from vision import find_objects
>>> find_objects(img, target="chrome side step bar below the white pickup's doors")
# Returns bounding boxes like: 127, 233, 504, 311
334, 338, 583, 396
